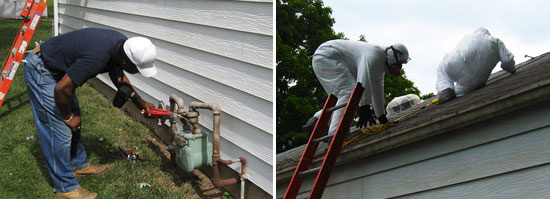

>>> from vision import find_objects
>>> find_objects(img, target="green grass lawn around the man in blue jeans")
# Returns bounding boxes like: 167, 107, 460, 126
0, 1, 230, 198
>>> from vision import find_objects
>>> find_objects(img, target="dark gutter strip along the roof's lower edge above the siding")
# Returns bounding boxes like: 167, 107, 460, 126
277, 79, 550, 183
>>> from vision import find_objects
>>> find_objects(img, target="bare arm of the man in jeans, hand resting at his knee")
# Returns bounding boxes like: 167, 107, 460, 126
54, 74, 80, 132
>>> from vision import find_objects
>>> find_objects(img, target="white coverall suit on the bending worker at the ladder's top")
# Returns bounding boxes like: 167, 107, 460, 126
312, 40, 391, 134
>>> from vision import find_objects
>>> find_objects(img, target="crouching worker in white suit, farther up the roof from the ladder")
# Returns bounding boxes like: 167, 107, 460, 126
436, 28, 516, 103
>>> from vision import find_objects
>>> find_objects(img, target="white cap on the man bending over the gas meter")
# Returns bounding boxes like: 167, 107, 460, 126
124, 37, 157, 77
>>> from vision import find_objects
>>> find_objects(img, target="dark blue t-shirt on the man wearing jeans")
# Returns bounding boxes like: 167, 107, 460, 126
40, 28, 128, 86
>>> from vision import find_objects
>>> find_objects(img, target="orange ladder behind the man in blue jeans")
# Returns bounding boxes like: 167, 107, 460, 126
0, 0, 48, 108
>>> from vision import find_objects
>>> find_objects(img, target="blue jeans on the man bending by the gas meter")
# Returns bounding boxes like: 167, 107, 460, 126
23, 52, 88, 192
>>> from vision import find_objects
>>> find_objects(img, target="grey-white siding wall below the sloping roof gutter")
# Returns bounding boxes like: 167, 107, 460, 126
277, 104, 550, 199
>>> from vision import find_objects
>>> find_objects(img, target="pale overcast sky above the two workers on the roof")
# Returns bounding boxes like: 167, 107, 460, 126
323, 0, 550, 94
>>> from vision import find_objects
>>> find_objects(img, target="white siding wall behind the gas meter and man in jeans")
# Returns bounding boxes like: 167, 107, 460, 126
55, 0, 273, 194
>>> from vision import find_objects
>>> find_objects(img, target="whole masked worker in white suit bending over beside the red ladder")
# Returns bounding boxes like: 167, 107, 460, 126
303, 40, 410, 134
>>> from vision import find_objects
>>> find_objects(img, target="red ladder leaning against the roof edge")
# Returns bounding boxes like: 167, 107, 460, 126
284, 83, 364, 199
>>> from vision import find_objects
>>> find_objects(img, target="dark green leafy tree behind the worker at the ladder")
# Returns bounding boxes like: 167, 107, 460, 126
276, 0, 434, 153
